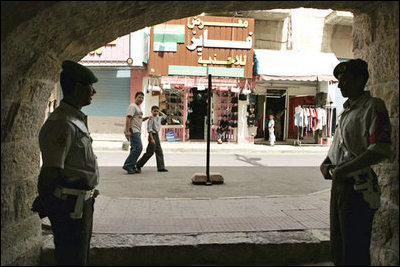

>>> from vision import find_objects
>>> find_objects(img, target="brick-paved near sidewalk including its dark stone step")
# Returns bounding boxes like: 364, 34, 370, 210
41, 190, 332, 266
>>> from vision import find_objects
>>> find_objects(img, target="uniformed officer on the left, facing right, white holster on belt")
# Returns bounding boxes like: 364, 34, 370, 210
32, 60, 99, 266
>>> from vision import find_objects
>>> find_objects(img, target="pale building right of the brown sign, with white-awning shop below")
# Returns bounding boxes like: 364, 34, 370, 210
209, 8, 353, 143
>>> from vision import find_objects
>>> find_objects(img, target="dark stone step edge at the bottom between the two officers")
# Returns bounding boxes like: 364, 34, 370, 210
40, 229, 330, 266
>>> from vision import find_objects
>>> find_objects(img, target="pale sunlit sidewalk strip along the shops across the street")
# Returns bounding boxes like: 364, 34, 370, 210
91, 133, 329, 153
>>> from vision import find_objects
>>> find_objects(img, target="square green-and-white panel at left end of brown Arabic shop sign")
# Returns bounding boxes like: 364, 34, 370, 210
153, 24, 185, 52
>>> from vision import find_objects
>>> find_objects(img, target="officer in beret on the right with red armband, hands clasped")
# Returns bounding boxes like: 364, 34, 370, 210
320, 59, 391, 266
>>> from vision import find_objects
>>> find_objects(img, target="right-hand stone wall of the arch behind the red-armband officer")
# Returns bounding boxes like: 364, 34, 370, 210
353, 2, 399, 265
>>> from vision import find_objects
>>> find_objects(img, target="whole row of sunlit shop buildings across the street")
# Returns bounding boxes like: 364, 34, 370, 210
49, 8, 353, 146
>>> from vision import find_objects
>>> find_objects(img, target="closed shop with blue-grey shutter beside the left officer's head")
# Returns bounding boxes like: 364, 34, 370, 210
79, 29, 149, 134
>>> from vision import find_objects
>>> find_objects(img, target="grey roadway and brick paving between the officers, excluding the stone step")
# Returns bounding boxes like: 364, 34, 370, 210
90, 151, 330, 234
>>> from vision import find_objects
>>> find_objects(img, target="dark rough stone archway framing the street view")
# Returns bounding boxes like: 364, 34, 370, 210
1, 1, 399, 265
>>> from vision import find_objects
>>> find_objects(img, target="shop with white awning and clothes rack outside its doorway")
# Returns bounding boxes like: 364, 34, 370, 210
254, 50, 339, 143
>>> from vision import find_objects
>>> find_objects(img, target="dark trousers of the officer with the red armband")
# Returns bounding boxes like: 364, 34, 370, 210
330, 178, 375, 266
